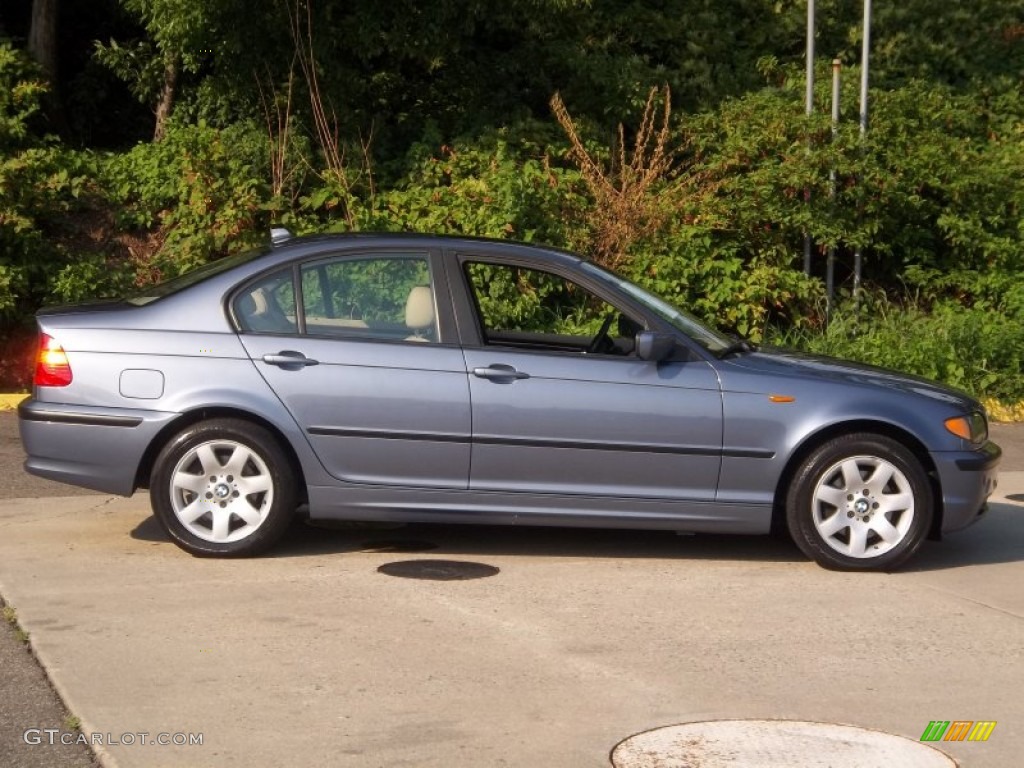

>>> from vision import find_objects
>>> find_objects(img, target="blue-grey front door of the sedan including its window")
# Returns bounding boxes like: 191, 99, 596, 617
452, 258, 722, 501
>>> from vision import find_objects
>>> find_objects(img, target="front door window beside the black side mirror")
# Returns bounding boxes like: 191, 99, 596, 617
465, 262, 643, 355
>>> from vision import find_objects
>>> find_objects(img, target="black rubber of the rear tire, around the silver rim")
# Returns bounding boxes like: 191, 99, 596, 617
150, 419, 297, 557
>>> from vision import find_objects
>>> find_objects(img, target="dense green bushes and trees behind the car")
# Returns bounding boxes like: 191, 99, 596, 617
0, 0, 1024, 409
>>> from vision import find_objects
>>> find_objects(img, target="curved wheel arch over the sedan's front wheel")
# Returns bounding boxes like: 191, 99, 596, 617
771, 419, 943, 540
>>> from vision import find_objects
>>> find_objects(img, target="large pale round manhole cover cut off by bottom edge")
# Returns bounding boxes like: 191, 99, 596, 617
611, 720, 956, 768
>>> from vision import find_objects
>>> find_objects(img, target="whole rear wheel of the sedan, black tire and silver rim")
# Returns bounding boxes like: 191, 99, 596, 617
150, 419, 298, 557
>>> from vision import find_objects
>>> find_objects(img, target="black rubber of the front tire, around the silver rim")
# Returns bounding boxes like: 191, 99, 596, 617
785, 433, 934, 570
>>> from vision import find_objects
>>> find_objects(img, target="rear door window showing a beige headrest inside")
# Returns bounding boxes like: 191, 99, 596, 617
301, 254, 438, 342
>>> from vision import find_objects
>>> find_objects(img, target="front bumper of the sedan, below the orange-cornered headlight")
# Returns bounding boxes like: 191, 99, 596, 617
932, 442, 1002, 534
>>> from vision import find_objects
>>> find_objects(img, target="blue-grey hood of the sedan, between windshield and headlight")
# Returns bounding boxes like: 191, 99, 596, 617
728, 347, 981, 411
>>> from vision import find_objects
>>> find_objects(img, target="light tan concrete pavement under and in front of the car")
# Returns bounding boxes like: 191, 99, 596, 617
0, 415, 1024, 768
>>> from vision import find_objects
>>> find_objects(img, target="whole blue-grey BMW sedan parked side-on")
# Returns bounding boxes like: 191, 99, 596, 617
18, 230, 1000, 569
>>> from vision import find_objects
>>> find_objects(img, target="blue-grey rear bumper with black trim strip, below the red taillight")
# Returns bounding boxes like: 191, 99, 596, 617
17, 399, 177, 496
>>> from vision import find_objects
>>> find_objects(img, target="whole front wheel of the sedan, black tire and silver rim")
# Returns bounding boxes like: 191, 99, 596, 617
785, 433, 934, 570
